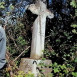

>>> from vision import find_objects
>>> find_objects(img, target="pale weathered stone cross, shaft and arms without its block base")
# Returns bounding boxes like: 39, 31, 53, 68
28, 0, 54, 59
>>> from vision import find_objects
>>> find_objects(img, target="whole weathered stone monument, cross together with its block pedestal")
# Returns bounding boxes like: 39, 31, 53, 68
20, 0, 54, 77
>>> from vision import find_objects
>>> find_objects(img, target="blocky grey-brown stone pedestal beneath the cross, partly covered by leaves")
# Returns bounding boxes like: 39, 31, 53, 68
19, 58, 52, 77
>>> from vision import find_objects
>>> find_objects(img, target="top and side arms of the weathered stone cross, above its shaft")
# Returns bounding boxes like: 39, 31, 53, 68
28, 1, 54, 18
